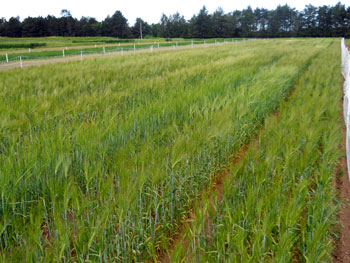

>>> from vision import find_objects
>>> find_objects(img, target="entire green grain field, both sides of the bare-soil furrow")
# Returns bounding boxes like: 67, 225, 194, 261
0, 39, 343, 262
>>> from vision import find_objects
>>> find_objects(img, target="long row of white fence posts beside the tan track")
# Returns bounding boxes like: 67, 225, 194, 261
0, 39, 254, 69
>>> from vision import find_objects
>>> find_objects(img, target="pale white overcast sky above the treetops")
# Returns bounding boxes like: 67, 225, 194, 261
0, 0, 346, 25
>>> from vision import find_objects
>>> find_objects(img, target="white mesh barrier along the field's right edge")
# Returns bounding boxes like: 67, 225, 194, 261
340, 38, 350, 180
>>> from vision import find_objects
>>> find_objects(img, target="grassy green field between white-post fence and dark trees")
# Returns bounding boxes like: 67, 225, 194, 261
0, 37, 247, 63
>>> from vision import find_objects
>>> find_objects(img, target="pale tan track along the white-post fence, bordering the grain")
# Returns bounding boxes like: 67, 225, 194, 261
0, 39, 254, 70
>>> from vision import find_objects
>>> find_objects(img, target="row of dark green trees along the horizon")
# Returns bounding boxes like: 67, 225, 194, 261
0, 2, 350, 38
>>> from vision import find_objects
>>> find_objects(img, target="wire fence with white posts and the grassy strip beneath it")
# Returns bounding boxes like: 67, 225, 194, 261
0, 39, 254, 69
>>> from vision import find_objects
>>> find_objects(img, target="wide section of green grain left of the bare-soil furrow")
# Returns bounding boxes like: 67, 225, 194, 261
0, 39, 340, 262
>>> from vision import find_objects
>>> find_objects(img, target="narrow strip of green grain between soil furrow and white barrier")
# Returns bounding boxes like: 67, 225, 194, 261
174, 41, 344, 262
